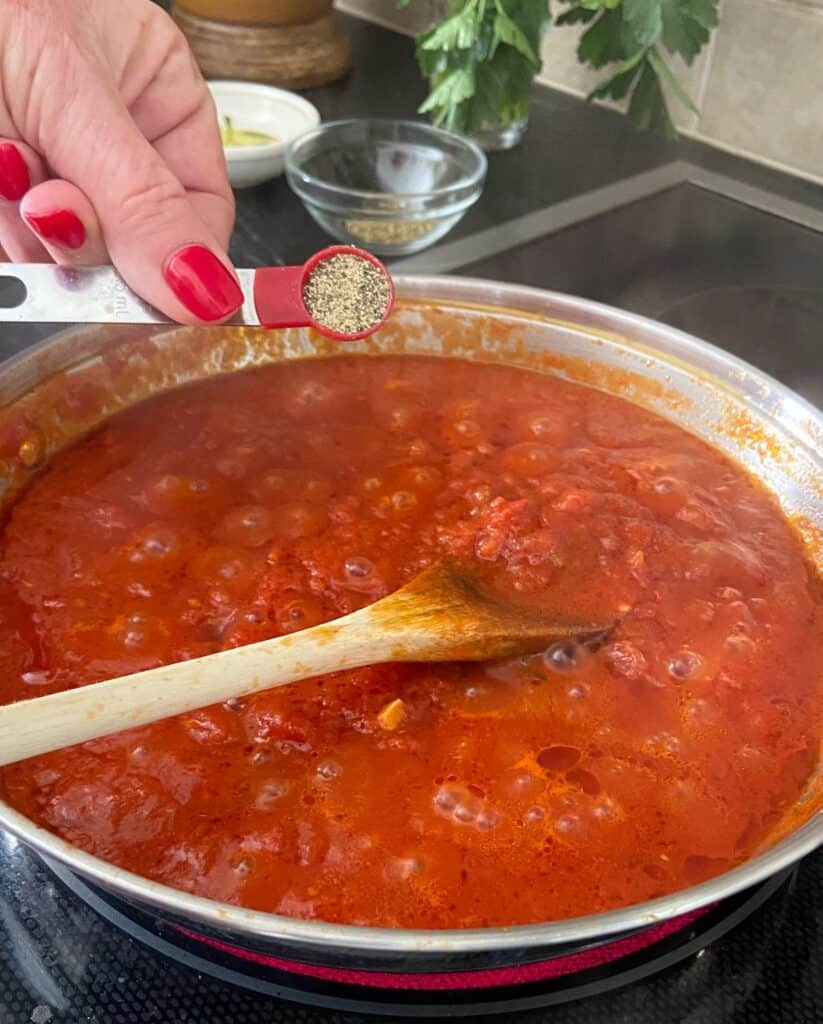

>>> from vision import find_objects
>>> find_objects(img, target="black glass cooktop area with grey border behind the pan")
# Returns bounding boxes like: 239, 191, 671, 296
392, 164, 823, 407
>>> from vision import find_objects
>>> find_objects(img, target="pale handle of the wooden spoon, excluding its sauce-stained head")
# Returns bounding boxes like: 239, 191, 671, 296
0, 605, 399, 765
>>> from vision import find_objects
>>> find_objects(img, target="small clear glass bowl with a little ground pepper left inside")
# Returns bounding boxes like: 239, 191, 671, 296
286, 119, 486, 256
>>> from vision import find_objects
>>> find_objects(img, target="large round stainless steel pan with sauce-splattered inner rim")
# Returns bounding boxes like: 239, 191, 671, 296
0, 278, 823, 971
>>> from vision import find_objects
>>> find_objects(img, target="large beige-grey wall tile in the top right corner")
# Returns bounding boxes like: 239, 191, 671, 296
697, 0, 823, 177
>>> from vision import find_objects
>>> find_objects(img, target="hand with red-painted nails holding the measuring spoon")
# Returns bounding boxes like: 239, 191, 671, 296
0, 0, 243, 324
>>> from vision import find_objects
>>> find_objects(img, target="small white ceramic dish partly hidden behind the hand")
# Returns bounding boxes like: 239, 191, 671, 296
208, 81, 320, 188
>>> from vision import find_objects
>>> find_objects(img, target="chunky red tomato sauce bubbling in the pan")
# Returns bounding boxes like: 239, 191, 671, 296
0, 356, 823, 928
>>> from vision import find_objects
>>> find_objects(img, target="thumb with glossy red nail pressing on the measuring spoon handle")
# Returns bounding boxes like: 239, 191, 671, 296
46, 81, 243, 324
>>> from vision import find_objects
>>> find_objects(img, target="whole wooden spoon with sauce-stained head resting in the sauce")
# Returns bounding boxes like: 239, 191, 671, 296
0, 560, 614, 765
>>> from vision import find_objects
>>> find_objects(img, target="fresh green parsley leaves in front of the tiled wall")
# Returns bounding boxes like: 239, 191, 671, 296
398, 0, 718, 138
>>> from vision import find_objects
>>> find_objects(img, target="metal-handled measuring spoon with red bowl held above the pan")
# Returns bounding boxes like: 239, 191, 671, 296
0, 246, 394, 341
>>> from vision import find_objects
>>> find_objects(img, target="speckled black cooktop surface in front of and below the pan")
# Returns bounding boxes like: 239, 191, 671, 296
0, 834, 823, 1024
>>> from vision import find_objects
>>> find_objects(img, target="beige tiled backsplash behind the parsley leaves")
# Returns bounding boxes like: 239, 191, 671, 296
337, 0, 823, 182
